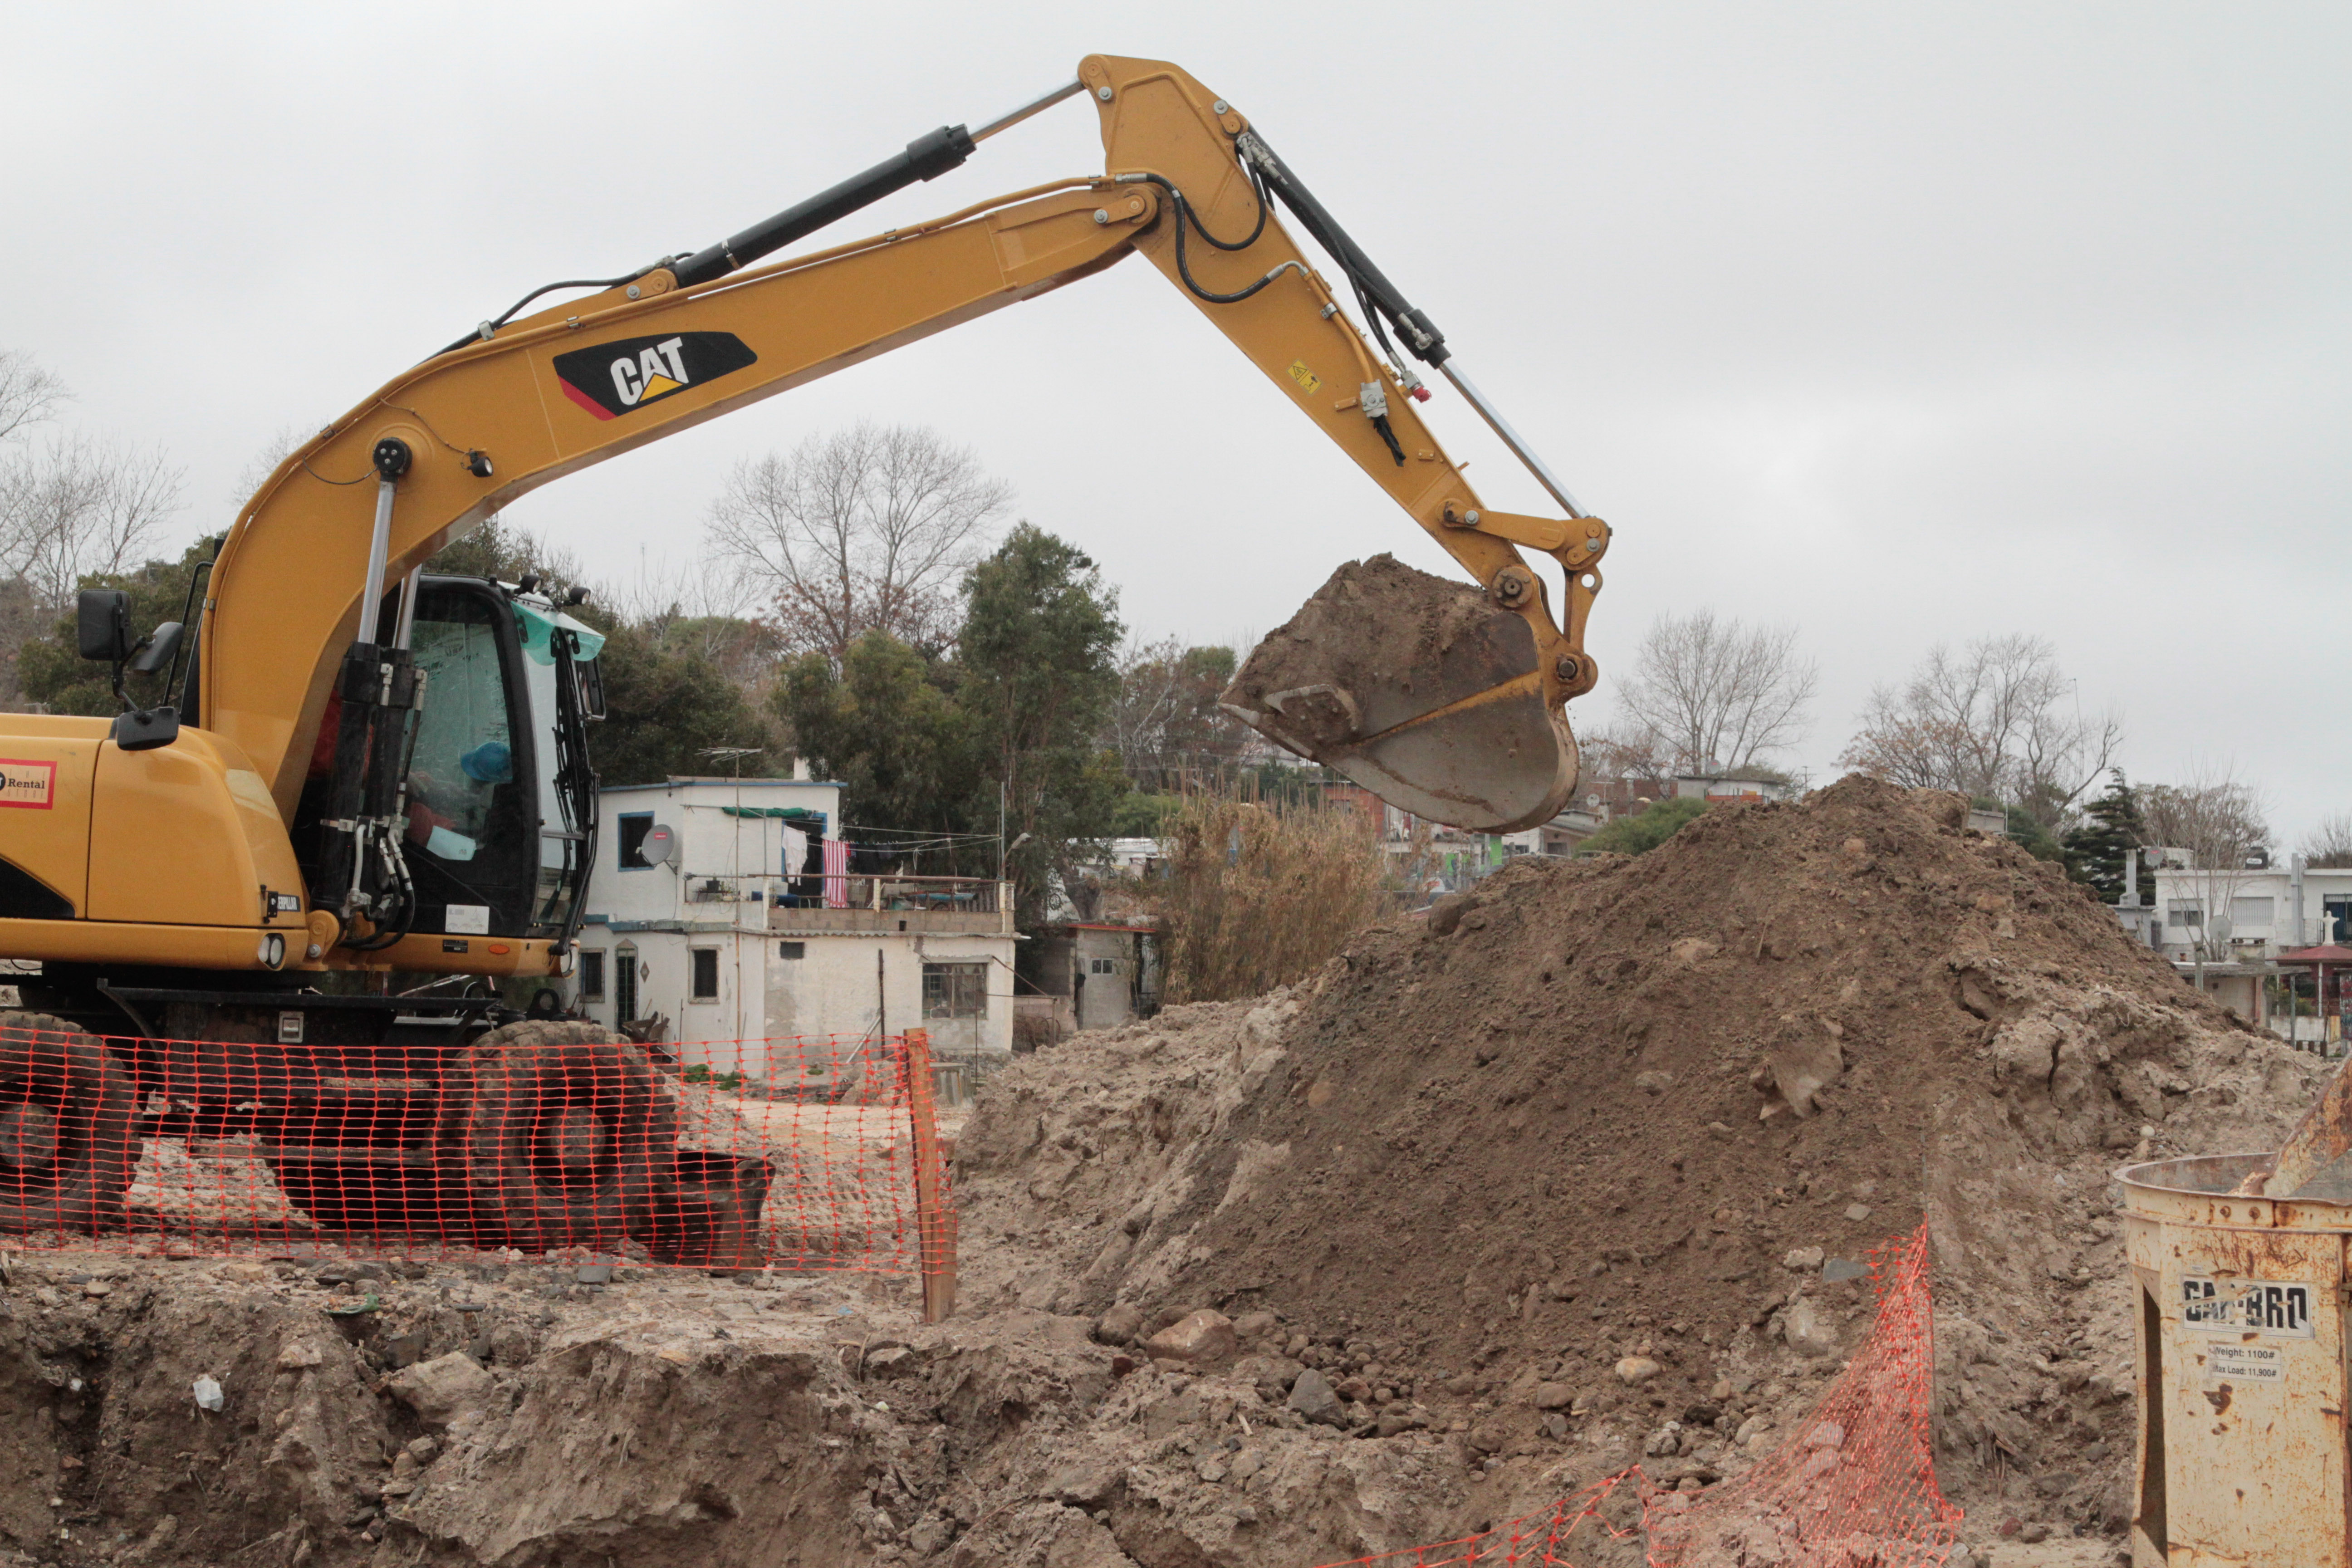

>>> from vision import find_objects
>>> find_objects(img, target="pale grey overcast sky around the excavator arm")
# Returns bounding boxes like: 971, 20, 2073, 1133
0, 0, 2352, 844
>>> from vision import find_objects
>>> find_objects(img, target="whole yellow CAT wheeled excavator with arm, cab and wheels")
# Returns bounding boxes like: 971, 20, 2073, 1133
0, 54, 1609, 1246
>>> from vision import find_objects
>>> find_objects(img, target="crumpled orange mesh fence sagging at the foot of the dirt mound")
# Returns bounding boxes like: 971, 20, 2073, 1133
1322, 1225, 1961, 1568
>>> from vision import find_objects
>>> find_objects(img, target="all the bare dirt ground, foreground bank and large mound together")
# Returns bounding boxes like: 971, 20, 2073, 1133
0, 780, 2319, 1568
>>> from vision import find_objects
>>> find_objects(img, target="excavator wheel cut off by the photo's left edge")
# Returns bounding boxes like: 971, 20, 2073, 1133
0, 1013, 139, 1234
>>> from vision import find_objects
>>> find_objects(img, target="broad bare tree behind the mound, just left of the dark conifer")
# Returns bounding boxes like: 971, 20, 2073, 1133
1837, 635, 2124, 828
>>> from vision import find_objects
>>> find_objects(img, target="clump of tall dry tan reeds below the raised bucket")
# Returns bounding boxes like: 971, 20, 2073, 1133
1152, 794, 1392, 1001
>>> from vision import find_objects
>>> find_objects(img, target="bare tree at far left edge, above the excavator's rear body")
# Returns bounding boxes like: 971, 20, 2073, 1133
0, 435, 183, 609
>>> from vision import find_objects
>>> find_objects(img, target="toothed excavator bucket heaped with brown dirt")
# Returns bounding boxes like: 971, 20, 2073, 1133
1223, 555, 1576, 832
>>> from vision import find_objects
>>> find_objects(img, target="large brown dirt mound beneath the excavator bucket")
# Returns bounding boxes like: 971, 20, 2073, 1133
960, 778, 2319, 1533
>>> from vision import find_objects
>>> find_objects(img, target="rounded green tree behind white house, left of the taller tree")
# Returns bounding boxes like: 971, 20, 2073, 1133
774, 630, 995, 832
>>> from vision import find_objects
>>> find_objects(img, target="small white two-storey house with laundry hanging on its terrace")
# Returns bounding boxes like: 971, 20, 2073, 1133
574, 778, 1016, 1079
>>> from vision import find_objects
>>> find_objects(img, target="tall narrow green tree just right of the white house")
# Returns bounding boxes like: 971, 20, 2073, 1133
957, 522, 1127, 919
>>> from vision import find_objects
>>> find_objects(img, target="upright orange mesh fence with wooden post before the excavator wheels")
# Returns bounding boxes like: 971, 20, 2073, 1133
0, 1011, 955, 1300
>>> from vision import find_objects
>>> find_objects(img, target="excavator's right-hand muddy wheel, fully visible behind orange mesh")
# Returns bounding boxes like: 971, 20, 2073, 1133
433, 1018, 677, 1251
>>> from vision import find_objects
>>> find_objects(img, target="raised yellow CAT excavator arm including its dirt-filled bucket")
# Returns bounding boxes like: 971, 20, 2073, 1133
195, 56, 1609, 959
